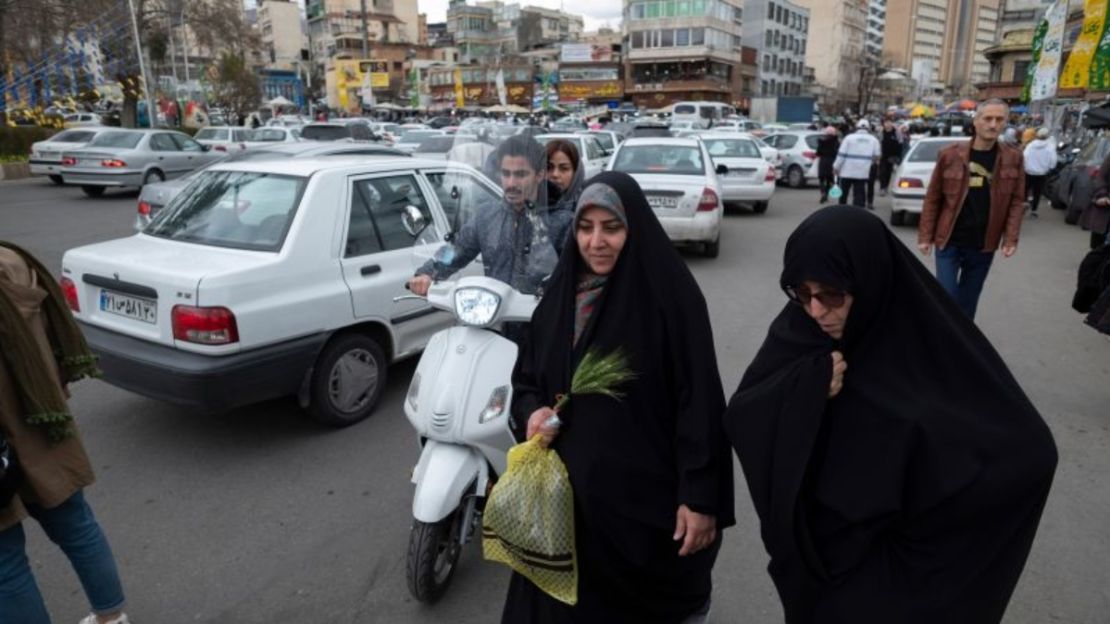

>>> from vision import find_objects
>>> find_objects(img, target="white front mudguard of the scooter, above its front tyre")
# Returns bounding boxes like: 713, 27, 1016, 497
413, 440, 488, 523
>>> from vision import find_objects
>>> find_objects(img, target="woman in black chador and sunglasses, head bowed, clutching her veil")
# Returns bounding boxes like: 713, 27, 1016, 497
725, 207, 1057, 624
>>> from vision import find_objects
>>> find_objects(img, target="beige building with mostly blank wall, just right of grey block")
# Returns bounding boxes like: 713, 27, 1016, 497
797, 0, 870, 111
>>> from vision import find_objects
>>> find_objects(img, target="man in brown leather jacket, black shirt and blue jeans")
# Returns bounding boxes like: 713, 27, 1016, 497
917, 100, 1026, 319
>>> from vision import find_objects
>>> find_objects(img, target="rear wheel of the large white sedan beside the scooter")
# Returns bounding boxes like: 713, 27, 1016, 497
309, 333, 389, 426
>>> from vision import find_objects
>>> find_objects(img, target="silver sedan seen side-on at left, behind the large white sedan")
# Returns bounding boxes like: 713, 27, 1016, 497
61, 129, 222, 198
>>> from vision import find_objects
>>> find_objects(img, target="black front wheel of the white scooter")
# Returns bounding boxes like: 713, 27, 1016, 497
406, 510, 463, 603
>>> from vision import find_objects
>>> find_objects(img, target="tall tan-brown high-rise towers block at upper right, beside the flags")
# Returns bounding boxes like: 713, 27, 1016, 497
882, 0, 999, 97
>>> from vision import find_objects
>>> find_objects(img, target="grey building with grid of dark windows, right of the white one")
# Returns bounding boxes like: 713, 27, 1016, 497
744, 0, 809, 95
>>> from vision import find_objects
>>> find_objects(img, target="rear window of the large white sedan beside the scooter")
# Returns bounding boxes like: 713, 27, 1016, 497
143, 171, 305, 251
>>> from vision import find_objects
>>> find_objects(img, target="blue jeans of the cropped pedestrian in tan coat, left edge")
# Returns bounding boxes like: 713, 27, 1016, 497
0, 491, 123, 624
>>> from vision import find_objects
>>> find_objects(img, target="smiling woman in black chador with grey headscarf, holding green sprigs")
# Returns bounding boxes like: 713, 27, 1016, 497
503, 172, 735, 624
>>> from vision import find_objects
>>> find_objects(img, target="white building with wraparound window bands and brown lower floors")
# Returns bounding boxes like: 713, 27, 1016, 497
623, 0, 744, 108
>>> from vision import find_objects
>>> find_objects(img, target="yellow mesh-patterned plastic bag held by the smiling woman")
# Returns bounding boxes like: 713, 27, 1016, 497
482, 435, 578, 605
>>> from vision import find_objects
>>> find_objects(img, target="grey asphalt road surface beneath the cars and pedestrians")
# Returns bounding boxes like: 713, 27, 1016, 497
0, 180, 1110, 624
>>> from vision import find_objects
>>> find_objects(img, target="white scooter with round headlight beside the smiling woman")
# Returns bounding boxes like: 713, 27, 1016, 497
405, 276, 536, 603
